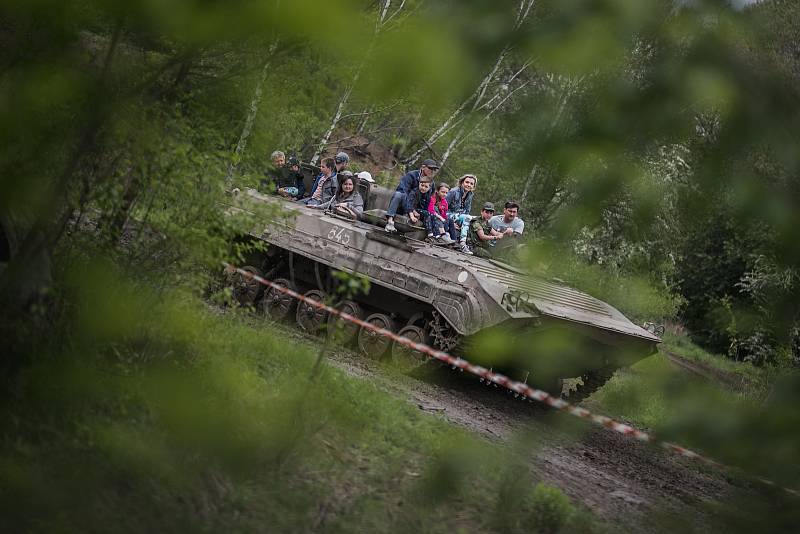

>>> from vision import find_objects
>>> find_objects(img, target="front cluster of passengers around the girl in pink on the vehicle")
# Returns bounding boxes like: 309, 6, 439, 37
386, 159, 525, 257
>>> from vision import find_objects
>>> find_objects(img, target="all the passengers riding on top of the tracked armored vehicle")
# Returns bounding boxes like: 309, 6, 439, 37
261, 151, 525, 257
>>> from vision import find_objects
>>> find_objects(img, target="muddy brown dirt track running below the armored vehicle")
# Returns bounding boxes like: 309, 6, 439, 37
308, 333, 734, 532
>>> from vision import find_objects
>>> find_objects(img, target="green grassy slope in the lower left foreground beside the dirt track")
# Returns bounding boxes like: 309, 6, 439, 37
0, 280, 590, 532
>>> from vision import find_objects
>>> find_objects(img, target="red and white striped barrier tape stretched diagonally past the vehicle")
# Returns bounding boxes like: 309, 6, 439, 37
224, 263, 800, 497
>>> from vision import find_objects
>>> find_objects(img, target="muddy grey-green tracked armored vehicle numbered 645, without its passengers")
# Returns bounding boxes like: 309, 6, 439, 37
225, 170, 660, 400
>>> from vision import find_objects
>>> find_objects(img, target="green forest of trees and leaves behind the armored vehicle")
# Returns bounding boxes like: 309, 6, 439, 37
0, 0, 800, 532
